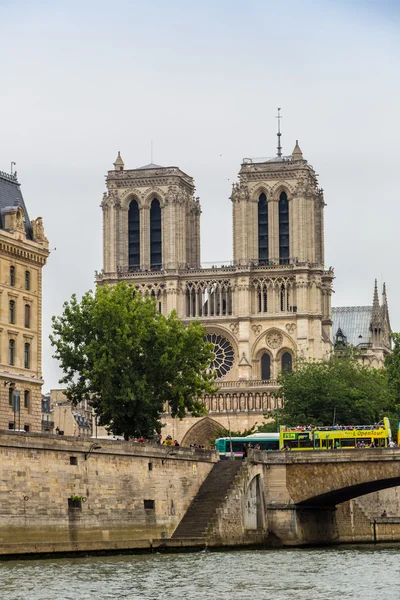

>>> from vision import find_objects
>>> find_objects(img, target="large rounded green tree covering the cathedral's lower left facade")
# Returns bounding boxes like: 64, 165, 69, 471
50, 283, 219, 438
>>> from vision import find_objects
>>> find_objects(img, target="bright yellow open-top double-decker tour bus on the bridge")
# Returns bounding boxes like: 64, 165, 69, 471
279, 417, 392, 450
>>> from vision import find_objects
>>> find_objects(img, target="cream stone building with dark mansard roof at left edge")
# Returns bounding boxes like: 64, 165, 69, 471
0, 172, 49, 432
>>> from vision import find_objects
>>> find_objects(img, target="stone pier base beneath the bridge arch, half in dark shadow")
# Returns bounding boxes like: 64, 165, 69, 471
266, 504, 339, 546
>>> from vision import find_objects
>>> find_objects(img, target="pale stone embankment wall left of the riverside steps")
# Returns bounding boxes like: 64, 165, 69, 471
0, 431, 216, 554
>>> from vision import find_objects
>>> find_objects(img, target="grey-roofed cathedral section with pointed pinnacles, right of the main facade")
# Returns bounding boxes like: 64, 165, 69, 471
332, 279, 391, 368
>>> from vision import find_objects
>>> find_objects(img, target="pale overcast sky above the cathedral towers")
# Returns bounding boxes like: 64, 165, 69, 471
0, 0, 400, 391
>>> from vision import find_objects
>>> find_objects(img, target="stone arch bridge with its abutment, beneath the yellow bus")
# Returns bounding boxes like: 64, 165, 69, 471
209, 448, 400, 546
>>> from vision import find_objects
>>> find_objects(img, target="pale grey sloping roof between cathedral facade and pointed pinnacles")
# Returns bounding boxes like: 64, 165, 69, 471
332, 306, 372, 346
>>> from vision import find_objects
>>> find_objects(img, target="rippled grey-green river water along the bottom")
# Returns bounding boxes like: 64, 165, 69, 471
0, 546, 400, 600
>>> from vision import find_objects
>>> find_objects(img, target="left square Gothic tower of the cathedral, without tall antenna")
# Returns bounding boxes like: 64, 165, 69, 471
101, 152, 200, 274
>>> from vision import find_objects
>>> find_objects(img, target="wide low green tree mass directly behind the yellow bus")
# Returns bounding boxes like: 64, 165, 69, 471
277, 350, 396, 425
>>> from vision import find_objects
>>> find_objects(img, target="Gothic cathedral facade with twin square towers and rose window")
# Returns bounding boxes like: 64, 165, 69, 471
97, 134, 334, 444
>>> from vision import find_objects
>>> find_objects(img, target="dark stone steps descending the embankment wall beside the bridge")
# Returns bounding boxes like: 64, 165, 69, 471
172, 460, 242, 538
